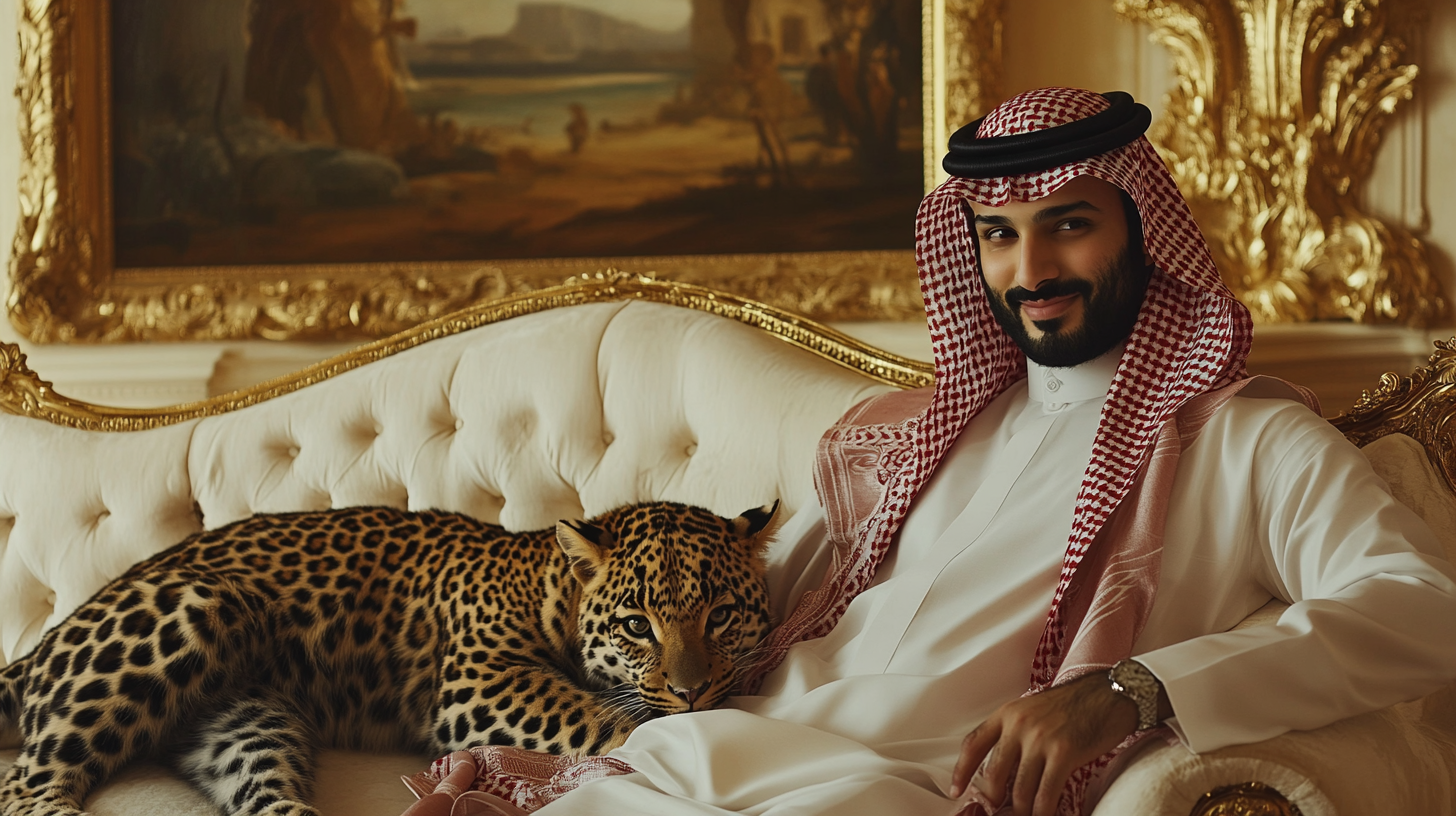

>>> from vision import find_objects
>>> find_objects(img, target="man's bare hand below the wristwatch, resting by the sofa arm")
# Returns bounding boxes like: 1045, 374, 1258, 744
951, 672, 1153, 816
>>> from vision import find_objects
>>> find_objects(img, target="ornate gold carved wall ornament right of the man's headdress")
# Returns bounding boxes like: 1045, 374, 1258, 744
1115, 0, 1447, 326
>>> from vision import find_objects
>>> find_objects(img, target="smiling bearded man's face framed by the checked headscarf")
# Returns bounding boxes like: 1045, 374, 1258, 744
967, 176, 1152, 367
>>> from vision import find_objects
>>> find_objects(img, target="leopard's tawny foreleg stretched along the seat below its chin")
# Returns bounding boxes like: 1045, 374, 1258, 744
432, 664, 636, 756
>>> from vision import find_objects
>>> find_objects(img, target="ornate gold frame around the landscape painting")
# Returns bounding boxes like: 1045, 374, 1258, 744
6, 0, 1003, 342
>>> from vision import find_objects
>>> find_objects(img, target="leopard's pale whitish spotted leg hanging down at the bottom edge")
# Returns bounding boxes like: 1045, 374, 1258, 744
176, 688, 319, 816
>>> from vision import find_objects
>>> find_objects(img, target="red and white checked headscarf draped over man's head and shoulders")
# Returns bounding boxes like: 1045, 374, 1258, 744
404, 87, 1312, 816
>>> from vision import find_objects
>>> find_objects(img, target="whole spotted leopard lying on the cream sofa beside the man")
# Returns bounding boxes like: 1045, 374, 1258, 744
0, 501, 779, 816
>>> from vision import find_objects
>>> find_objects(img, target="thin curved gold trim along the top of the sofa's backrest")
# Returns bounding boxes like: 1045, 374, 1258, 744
0, 270, 933, 431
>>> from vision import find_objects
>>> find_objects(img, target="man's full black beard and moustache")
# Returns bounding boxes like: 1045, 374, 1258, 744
973, 233, 1153, 369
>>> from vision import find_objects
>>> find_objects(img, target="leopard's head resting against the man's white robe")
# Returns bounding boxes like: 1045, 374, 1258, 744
556, 501, 779, 720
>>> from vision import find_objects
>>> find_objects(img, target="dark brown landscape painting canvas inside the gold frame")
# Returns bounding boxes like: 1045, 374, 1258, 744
109, 0, 923, 270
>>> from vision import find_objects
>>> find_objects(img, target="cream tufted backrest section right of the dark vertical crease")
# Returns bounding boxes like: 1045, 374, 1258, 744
189, 302, 888, 529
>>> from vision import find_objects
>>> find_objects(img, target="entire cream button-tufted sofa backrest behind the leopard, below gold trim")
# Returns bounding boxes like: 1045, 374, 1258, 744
0, 300, 890, 663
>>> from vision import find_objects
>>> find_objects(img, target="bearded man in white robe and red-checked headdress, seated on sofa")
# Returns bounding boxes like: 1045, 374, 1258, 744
407, 89, 1456, 816
